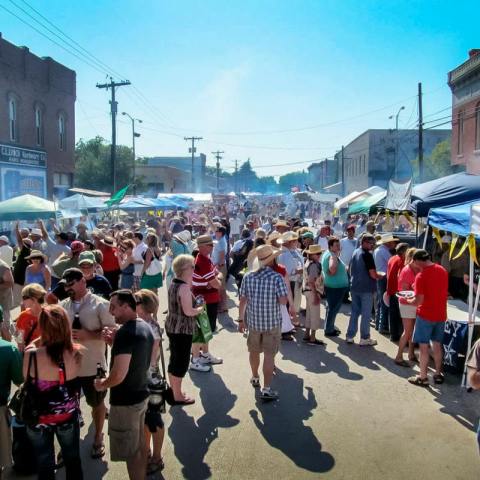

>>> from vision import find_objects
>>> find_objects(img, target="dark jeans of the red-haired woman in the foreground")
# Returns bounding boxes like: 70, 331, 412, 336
27, 419, 83, 480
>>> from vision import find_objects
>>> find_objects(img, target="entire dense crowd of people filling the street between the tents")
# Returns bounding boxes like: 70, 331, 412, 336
0, 201, 480, 479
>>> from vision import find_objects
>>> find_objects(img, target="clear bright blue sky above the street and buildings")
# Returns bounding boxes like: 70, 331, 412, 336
0, 0, 480, 175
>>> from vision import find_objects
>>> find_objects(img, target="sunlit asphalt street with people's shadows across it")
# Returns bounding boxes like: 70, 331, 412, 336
7, 284, 480, 480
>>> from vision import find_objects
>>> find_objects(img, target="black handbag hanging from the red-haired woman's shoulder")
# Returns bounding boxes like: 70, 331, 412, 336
8, 352, 40, 426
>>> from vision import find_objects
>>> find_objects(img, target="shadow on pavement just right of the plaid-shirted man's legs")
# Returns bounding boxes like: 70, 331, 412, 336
280, 332, 363, 380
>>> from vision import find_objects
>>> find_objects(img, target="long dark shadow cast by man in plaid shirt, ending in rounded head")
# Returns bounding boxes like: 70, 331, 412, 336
250, 369, 335, 476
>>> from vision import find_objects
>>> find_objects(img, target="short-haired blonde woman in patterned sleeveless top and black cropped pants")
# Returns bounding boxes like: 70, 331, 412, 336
165, 254, 204, 405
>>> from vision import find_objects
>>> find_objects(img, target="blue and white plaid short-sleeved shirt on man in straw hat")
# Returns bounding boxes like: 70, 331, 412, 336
240, 267, 287, 332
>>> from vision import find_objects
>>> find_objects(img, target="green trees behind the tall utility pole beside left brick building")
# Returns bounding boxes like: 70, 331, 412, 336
74, 136, 143, 192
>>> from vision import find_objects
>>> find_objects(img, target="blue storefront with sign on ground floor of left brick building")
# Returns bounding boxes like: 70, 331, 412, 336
0, 143, 47, 200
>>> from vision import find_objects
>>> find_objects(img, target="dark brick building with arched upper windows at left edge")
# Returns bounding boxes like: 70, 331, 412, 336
0, 34, 76, 200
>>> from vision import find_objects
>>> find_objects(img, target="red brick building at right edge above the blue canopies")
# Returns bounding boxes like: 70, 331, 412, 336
448, 49, 480, 175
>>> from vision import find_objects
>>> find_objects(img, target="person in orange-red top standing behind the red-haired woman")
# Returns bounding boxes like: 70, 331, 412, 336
15, 283, 47, 352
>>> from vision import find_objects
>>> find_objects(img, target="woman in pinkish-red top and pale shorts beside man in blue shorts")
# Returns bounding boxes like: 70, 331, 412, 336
395, 248, 419, 367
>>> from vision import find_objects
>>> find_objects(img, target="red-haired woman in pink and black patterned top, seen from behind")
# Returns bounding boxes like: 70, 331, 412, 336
23, 305, 83, 480
